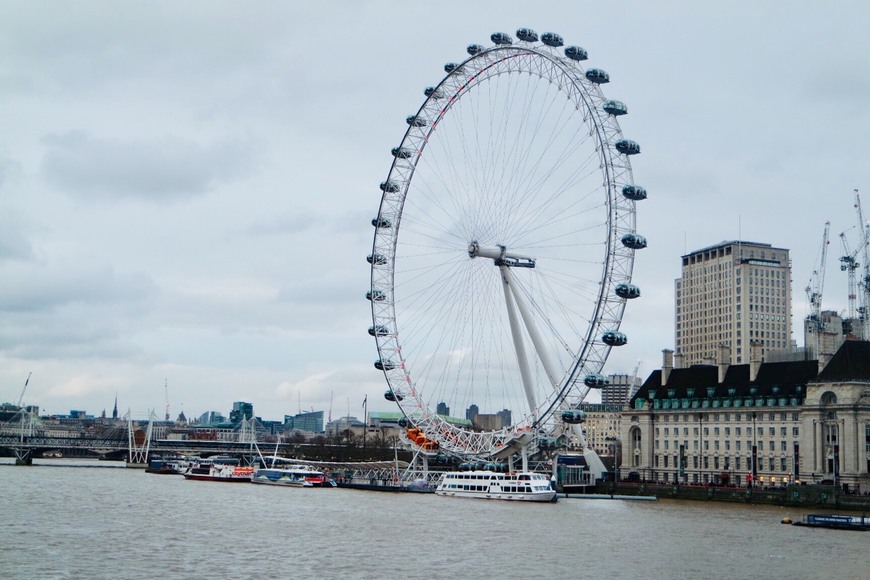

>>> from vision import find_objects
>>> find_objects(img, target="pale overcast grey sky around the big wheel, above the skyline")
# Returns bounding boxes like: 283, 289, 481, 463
0, 0, 870, 419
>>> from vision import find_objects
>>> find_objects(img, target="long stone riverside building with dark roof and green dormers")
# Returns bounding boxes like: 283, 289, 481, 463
620, 341, 870, 491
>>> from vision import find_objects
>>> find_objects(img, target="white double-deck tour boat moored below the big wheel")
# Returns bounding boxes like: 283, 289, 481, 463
435, 471, 556, 501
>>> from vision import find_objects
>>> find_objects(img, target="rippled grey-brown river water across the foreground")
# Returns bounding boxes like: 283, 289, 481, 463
0, 460, 870, 579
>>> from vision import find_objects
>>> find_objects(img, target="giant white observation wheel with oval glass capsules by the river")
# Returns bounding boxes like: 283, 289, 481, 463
367, 29, 646, 457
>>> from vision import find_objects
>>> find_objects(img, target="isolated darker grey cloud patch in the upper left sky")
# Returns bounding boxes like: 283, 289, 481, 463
42, 131, 253, 202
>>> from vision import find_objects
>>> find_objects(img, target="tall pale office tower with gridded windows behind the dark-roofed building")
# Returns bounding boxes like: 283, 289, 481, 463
675, 241, 791, 367
